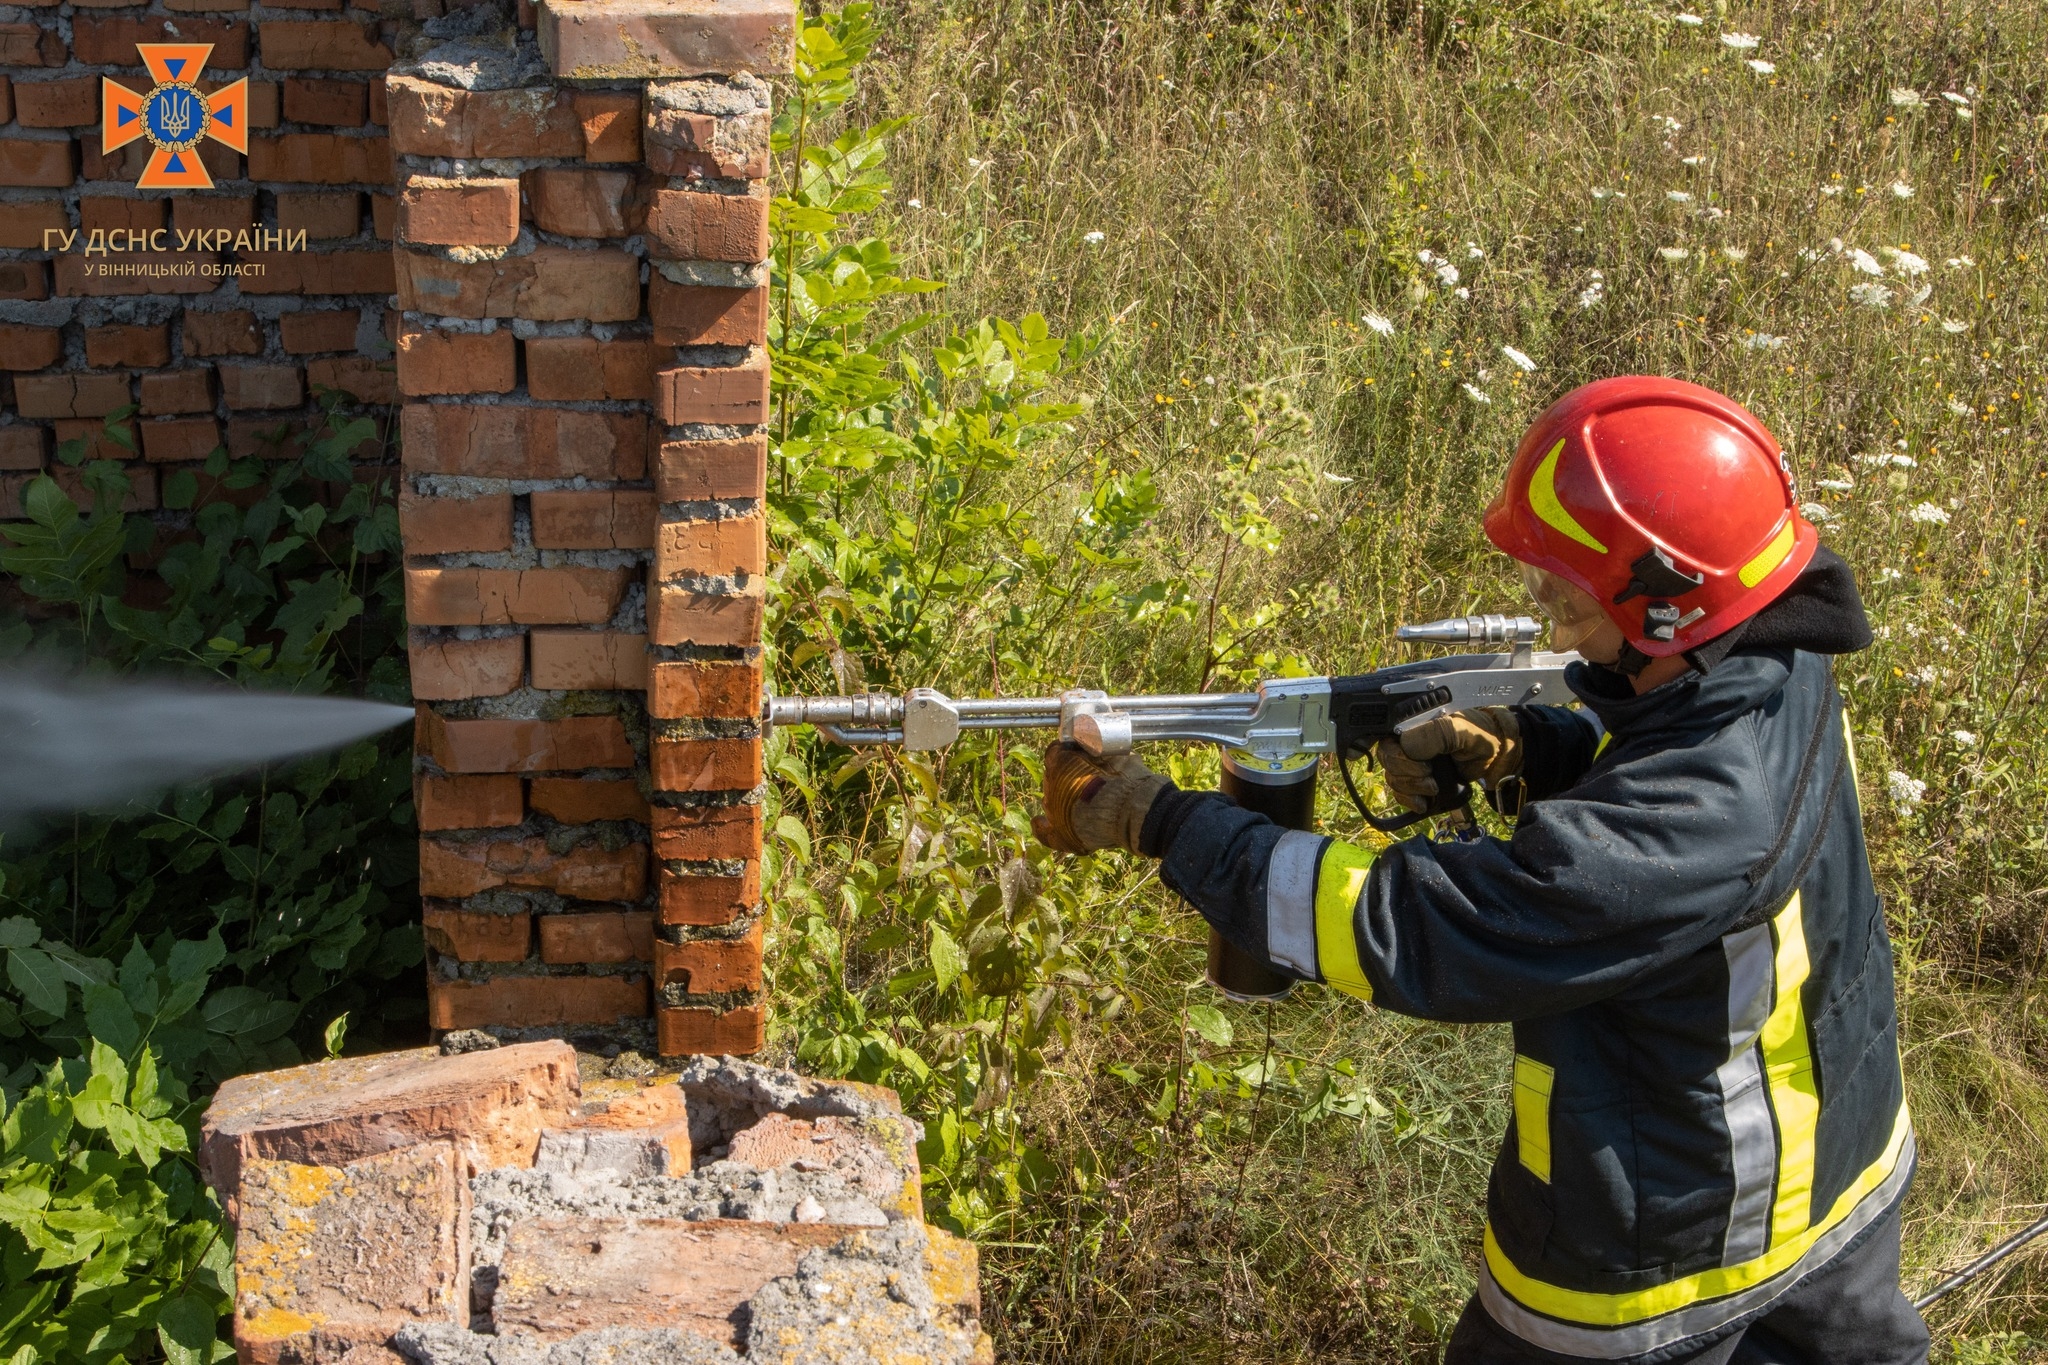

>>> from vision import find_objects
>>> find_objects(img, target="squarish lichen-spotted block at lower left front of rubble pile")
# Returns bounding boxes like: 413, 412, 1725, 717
236, 1142, 469, 1365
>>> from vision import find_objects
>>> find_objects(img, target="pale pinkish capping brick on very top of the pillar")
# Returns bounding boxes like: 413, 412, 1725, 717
539, 0, 795, 80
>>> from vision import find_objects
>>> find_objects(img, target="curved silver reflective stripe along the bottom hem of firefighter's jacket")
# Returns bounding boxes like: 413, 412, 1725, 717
1479, 1132, 1917, 1361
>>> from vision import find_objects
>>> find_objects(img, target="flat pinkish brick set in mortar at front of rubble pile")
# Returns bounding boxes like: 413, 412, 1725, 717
492, 1218, 846, 1347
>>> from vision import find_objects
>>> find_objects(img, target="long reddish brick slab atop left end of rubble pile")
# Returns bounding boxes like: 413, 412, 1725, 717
199, 1042, 580, 1218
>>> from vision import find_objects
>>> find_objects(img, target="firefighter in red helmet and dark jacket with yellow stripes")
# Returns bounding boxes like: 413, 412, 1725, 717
1034, 377, 1929, 1365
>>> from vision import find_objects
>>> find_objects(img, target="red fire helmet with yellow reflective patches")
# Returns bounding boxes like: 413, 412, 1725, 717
1485, 375, 1817, 657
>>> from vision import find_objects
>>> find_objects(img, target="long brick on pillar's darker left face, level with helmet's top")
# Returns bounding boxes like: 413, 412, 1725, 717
401, 403, 647, 479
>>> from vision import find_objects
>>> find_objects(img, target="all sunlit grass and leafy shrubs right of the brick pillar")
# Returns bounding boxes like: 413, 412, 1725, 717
770, 0, 2048, 1361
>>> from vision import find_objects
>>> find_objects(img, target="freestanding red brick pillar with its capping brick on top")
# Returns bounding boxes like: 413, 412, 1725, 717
387, 0, 793, 1054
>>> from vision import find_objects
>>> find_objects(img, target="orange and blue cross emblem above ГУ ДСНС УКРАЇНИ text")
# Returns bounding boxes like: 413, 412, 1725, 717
100, 43, 250, 190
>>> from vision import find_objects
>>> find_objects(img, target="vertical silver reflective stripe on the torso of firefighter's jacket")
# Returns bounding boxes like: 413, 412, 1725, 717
1714, 925, 1778, 1265
